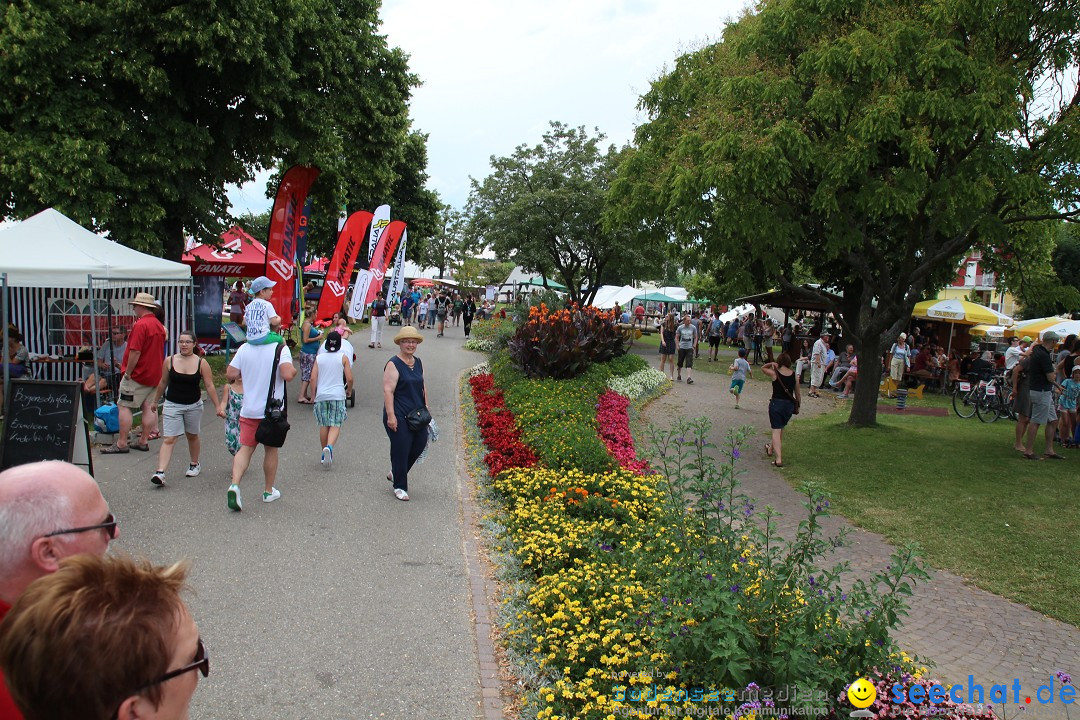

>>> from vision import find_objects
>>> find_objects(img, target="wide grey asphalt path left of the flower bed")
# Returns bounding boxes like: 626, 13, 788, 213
94, 328, 484, 720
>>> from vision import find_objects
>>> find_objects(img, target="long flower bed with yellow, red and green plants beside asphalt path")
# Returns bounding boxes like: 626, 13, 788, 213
470, 356, 924, 720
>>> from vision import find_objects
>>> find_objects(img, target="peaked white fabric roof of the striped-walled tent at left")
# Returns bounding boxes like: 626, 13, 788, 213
0, 208, 191, 288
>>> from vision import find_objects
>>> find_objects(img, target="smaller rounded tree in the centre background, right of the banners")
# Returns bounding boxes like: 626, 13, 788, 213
465, 122, 649, 303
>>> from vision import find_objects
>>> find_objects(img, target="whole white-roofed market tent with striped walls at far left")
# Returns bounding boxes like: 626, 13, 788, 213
0, 208, 192, 405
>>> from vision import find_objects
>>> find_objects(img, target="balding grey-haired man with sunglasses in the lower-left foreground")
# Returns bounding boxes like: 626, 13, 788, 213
0, 461, 120, 720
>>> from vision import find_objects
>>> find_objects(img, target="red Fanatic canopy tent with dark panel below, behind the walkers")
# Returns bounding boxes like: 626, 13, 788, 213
184, 226, 267, 352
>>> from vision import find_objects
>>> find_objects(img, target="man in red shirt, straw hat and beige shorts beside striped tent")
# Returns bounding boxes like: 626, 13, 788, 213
102, 293, 165, 454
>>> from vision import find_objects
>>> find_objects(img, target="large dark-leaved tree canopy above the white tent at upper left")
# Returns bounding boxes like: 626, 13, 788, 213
0, 0, 416, 258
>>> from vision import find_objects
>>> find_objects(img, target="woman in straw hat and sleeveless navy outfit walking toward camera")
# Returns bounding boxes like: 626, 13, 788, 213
382, 325, 431, 500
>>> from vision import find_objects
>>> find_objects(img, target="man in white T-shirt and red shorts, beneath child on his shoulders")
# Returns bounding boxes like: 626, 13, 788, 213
225, 342, 296, 512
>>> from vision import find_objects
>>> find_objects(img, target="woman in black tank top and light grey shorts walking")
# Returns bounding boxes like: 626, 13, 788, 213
150, 330, 225, 487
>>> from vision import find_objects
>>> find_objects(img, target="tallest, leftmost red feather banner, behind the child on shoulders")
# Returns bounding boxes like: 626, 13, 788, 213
266, 165, 319, 327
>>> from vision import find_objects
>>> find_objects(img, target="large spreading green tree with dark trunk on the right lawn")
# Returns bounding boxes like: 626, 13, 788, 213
615, 0, 1080, 425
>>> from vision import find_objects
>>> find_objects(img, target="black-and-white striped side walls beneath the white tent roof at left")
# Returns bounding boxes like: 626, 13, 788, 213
8, 280, 191, 381
